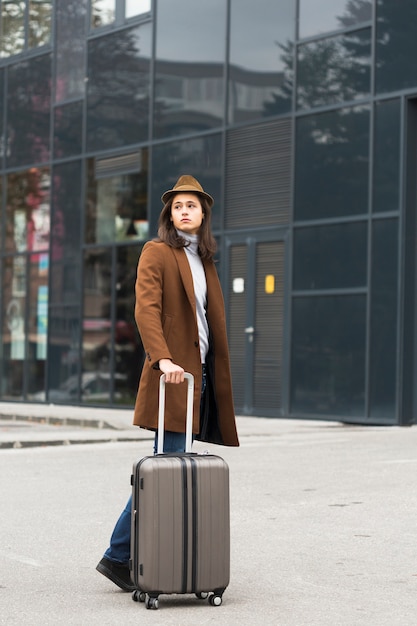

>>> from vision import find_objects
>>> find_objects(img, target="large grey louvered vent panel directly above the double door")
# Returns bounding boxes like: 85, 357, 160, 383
225, 119, 291, 228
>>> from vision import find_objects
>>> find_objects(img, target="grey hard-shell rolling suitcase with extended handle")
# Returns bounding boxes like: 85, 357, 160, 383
130, 374, 230, 609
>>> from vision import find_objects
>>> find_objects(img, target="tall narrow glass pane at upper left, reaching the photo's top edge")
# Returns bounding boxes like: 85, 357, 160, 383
55, 0, 88, 102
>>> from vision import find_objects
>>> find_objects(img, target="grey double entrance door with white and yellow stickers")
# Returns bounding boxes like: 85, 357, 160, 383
226, 232, 285, 417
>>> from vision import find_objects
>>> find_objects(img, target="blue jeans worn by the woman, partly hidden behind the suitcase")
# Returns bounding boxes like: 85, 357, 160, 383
104, 368, 206, 563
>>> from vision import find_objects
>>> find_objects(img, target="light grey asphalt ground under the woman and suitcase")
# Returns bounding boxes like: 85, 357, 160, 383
0, 420, 417, 626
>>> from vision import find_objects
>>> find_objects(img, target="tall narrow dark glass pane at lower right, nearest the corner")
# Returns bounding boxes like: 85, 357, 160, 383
369, 219, 398, 420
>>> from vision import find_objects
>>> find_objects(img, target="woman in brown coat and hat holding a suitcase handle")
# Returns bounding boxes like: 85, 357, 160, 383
97, 175, 239, 591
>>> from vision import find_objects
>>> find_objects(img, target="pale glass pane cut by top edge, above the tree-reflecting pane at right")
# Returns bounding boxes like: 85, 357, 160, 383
299, 0, 372, 37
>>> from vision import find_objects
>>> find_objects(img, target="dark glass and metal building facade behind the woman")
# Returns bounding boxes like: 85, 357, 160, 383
0, 0, 417, 425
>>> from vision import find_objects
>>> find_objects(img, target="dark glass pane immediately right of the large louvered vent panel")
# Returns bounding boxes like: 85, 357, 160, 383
295, 107, 370, 220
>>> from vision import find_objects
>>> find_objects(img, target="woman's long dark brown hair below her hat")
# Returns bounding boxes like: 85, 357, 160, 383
158, 192, 217, 261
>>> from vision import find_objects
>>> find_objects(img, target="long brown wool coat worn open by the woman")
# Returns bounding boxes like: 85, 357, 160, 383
134, 236, 239, 446
